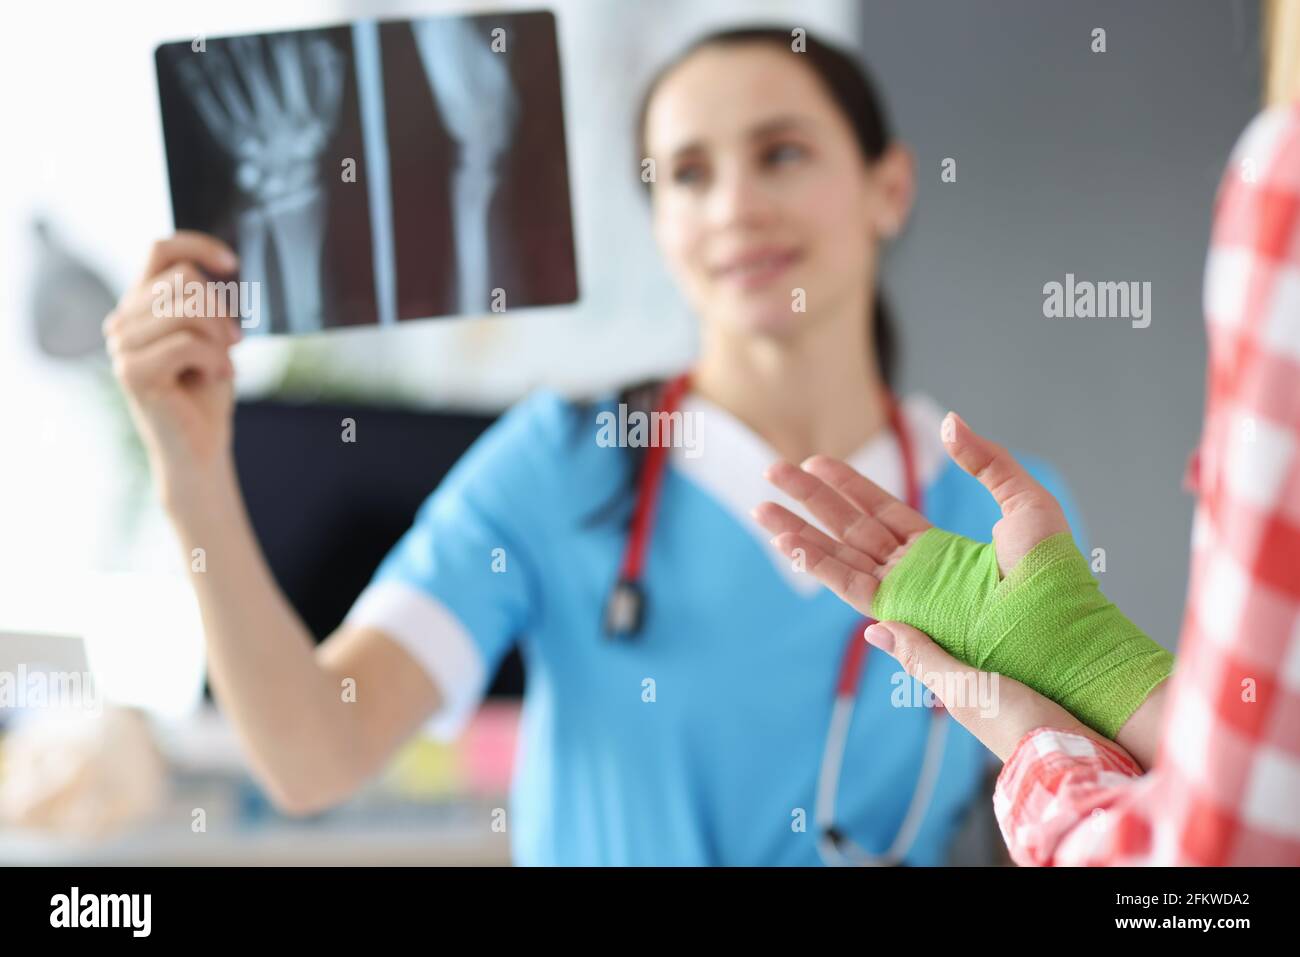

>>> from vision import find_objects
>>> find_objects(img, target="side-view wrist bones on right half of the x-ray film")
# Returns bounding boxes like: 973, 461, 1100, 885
411, 17, 519, 313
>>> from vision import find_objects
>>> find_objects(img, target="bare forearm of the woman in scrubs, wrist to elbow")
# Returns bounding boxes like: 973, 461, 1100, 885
166, 460, 363, 811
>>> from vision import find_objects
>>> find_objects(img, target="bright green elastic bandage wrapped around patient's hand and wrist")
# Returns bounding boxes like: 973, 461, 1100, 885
871, 528, 1174, 739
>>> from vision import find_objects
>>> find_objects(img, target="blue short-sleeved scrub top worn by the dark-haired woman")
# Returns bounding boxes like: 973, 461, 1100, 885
351, 393, 1083, 865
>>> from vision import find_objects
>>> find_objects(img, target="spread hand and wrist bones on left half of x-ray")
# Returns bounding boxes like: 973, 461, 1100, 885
181, 35, 343, 332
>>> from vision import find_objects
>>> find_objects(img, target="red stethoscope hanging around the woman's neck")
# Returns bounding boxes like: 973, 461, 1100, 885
605, 373, 948, 866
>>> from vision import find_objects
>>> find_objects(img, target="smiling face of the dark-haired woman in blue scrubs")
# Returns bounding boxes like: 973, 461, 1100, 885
644, 43, 897, 338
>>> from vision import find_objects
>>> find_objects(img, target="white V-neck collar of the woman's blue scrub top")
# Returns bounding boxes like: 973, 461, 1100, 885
670, 393, 948, 596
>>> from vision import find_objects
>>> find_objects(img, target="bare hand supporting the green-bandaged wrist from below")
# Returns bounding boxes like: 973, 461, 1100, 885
866, 622, 1132, 762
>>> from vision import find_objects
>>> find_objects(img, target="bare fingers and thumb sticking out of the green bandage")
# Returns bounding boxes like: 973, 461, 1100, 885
754, 412, 1070, 618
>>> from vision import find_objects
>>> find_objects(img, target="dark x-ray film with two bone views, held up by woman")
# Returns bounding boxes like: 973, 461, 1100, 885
156, 13, 577, 333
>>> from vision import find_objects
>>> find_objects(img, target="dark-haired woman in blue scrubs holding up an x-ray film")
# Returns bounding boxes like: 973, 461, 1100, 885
105, 30, 1078, 865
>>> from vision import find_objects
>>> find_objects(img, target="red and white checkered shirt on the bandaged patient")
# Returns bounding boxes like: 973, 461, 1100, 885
993, 104, 1300, 865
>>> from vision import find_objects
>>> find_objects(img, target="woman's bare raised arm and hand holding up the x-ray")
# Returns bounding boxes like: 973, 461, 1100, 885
104, 231, 439, 813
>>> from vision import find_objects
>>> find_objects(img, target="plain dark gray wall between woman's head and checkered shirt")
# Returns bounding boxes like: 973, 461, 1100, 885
863, 0, 1260, 648
